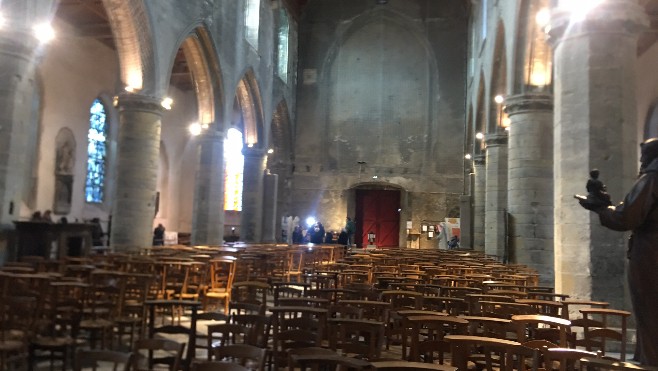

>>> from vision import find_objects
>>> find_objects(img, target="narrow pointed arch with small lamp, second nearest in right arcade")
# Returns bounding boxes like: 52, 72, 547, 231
487, 21, 507, 133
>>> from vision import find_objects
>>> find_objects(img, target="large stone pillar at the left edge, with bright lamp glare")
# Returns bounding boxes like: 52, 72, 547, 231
0, 0, 56, 266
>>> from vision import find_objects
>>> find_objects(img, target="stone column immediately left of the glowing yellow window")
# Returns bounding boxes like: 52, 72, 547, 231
192, 129, 224, 245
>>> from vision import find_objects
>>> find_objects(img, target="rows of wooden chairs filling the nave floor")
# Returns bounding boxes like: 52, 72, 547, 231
0, 244, 649, 371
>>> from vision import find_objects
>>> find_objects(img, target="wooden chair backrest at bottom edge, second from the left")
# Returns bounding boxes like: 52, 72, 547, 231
132, 339, 185, 371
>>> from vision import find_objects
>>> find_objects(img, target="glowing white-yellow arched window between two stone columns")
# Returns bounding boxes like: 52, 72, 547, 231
224, 128, 244, 211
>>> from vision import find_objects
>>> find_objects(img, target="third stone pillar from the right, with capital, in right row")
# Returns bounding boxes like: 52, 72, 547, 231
484, 131, 508, 261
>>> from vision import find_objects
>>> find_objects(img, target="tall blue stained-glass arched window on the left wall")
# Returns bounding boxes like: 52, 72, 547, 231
85, 99, 107, 203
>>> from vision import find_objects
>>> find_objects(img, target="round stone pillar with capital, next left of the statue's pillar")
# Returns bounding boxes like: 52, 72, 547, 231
505, 94, 555, 286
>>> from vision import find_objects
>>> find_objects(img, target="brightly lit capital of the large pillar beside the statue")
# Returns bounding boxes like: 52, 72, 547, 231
548, 0, 649, 47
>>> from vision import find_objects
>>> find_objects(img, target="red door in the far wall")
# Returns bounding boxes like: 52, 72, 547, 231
355, 190, 400, 247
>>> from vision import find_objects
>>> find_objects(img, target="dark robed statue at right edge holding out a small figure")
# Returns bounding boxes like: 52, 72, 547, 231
580, 138, 658, 366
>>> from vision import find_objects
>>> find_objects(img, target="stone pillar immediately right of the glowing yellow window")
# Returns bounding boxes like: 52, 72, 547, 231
240, 148, 267, 243
